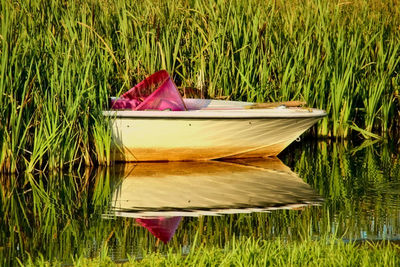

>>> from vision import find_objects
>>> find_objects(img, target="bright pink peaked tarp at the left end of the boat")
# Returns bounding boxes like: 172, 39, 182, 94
111, 70, 186, 111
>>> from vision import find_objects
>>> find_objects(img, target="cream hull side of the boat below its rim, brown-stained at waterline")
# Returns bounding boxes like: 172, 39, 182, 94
112, 117, 320, 162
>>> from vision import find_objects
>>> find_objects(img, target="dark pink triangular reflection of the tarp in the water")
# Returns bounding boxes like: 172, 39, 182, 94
136, 216, 182, 244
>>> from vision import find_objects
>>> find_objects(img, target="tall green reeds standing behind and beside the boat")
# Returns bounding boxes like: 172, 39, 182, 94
0, 0, 400, 172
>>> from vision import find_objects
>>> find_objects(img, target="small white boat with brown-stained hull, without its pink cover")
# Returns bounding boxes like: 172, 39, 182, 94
103, 99, 326, 162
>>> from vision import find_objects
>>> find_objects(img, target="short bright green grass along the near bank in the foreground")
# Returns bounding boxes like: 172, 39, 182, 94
24, 238, 400, 267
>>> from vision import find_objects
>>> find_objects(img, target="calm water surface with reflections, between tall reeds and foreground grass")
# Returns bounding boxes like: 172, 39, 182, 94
0, 141, 400, 265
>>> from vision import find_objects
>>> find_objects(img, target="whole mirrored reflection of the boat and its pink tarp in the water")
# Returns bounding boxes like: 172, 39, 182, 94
112, 158, 322, 243
